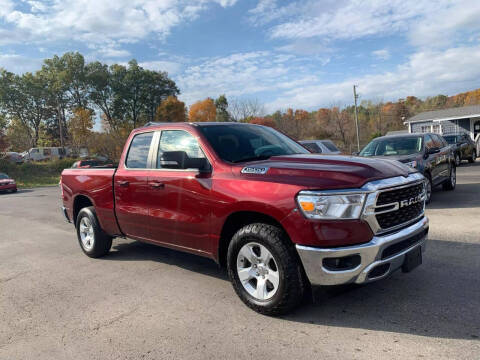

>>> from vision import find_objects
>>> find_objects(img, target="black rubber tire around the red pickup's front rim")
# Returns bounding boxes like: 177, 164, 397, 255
227, 223, 307, 315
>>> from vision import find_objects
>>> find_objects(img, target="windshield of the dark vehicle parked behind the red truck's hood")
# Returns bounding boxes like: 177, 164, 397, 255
360, 136, 422, 156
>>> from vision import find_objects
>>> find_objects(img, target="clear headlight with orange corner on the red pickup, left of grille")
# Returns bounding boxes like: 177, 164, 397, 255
297, 192, 366, 220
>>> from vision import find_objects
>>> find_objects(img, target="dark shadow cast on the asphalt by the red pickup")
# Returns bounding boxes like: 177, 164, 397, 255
107, 240, 480, 340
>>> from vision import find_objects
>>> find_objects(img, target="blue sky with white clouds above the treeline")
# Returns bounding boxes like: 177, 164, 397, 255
0, 0, 480, 111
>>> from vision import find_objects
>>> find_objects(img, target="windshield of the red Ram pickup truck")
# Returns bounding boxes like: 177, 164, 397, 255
200, 124, 309, 163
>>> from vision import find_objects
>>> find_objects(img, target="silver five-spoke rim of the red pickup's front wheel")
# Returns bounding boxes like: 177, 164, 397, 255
237, 242, 280, 300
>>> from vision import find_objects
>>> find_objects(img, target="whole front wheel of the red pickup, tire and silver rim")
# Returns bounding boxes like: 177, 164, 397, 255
227, 223, 305, 315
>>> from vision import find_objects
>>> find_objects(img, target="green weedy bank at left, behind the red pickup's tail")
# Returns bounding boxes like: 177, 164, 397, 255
0, 159, 76, 188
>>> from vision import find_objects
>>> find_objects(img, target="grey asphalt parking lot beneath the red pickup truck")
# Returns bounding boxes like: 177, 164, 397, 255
0, 161, 480, 360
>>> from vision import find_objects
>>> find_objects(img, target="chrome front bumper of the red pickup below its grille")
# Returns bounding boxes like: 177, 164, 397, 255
296, 217, 428, 285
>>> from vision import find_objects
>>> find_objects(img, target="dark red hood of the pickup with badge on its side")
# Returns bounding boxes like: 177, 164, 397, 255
234, 154, 416, 190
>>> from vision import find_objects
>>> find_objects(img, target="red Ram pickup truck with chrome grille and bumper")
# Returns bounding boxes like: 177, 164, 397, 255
61, 123, 428, 314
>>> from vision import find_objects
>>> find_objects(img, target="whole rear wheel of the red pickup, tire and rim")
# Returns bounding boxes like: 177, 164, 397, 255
76, 206, 112, 258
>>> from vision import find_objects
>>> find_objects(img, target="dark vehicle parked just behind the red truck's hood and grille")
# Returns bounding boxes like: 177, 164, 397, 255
359, 133, 457, 203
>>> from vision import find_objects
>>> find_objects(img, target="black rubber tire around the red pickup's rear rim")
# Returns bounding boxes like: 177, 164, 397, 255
75, 206, 112, 258
